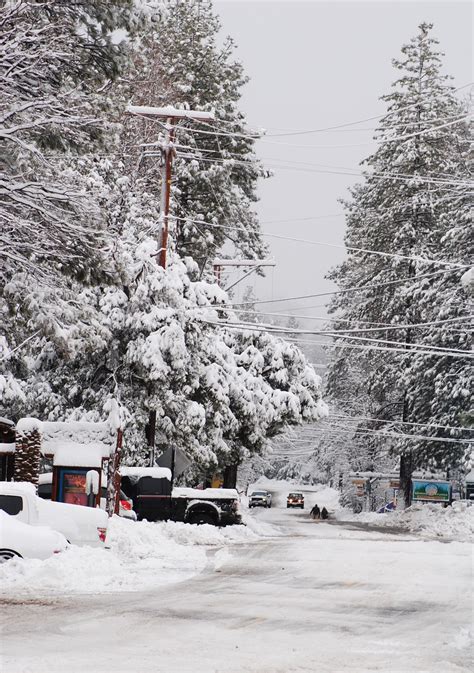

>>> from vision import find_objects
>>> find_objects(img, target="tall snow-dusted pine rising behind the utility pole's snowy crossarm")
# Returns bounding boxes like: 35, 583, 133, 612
120, 0, 267, 270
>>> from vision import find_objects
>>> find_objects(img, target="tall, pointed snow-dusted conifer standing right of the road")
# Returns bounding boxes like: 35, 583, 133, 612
329, 24, 469, 502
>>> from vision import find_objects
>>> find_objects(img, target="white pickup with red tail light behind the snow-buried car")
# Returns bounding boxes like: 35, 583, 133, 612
0, 481, 109, 547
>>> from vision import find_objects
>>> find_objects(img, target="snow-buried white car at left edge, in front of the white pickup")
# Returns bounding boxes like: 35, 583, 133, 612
0, 510, 68, 563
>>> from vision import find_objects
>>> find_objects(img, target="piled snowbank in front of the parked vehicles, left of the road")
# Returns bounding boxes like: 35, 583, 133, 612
0, 517, 275, 597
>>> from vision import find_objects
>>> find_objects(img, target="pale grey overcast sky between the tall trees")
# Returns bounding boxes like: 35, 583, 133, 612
215, 0, 473, 315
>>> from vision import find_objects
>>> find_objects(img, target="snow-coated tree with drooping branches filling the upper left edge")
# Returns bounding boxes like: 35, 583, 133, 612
0, 0, 132, 413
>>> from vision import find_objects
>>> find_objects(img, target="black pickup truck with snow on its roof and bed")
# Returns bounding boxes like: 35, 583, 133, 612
121, 468, 242, 526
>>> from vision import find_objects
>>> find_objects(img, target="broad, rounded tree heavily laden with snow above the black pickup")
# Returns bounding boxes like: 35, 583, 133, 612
14, 161, 325, 470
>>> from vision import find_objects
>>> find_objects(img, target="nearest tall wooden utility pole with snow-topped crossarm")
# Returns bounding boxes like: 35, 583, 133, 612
126, 105, 215, 467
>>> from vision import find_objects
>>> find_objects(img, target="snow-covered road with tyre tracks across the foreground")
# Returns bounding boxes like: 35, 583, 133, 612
1, 498, 472, 673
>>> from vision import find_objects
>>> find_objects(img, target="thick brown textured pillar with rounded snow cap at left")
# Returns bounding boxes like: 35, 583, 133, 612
13, 418, 43, 486
